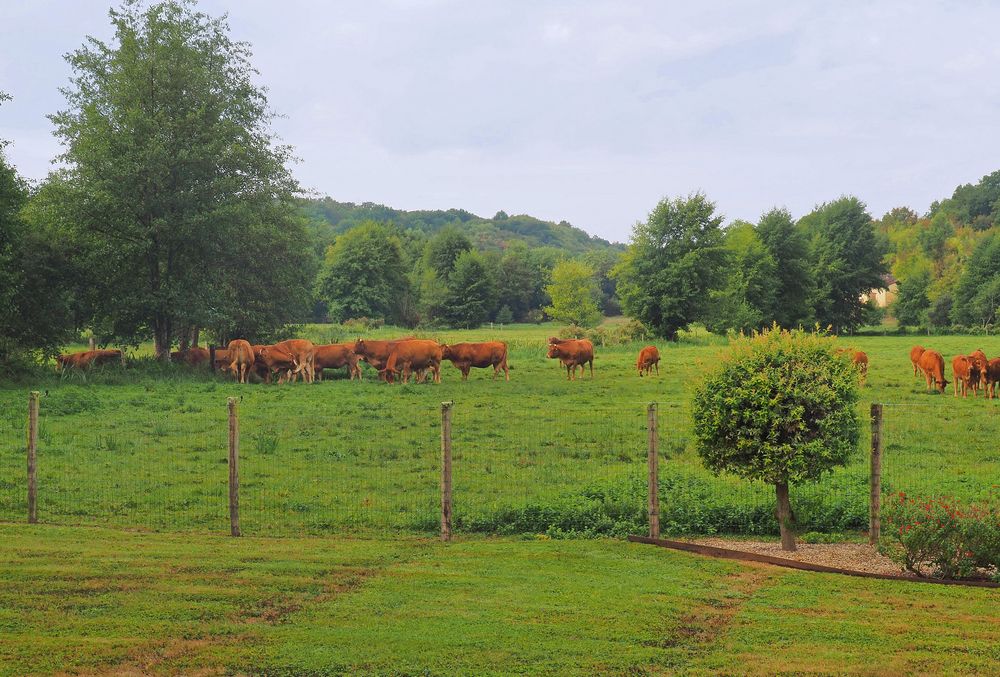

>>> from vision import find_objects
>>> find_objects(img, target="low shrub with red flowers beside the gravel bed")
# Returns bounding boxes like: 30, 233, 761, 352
879, 492, 1000, 578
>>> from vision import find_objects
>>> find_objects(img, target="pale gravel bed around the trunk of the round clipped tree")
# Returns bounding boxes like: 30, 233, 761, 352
685, 538, 913, 576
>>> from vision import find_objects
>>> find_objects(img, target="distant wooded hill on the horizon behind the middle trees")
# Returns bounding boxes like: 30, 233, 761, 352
301, 197, 625, 254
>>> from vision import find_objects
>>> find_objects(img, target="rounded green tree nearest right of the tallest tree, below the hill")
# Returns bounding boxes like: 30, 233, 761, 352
318, 221, 410, 323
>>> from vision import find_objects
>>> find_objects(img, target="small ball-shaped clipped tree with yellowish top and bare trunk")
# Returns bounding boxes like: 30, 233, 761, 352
692, 326, 860, 551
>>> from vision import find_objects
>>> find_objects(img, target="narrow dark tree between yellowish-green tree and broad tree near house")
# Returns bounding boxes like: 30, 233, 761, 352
757, 207, 813, 329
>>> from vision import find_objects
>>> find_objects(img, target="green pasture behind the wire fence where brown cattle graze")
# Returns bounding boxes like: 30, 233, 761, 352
0, 325, 1000, 536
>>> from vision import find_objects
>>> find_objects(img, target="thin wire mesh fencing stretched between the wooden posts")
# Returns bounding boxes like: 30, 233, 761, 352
0, 391, 1000, 536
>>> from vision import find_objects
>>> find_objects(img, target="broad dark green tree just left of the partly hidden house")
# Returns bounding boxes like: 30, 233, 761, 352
799, 196, 887, 331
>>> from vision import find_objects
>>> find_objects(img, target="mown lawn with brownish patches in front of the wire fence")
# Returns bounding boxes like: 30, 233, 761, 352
0, 524, 1000, 675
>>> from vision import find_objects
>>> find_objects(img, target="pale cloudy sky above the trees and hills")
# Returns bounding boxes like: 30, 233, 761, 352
0, 0, 1000, 241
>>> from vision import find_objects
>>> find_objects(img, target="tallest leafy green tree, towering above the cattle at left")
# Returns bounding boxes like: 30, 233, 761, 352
43, 0, 313, 359
